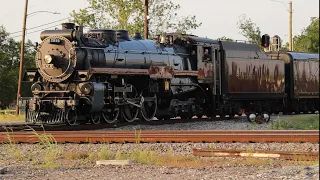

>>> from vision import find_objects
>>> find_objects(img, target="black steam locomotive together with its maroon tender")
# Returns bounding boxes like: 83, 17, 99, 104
23, 23, 319, 125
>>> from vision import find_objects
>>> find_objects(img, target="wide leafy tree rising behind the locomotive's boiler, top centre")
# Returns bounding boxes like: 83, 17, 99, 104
71, 0, 202, 36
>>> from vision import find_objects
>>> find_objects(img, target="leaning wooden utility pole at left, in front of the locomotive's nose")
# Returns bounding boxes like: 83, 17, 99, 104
16, 0, 28, 115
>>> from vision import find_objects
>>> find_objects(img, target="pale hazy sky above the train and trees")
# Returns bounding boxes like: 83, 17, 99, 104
0, 0, 319, 42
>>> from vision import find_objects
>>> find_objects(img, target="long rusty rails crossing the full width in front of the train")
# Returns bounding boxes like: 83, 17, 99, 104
0, 130, 319, 143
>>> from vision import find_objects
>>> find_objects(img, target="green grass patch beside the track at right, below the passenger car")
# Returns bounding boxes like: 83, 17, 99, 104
269, 114, 319, 130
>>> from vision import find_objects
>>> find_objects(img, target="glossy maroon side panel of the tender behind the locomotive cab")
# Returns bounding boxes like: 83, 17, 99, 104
226, 58, 285, 97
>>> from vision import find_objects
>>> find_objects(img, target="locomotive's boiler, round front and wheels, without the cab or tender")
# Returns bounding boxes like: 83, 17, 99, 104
26, 23, 204, 125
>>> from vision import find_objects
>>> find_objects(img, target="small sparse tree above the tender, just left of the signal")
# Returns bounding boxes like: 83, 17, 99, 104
238, 14, 261, 45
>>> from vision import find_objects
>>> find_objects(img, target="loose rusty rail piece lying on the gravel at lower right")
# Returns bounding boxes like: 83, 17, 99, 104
193, 148, 319, 161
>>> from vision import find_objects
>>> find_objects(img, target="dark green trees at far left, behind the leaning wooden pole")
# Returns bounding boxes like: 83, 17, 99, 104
0, 26, 35, 105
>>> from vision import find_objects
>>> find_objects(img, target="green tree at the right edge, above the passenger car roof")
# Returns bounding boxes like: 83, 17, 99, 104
293, 18, 319, 53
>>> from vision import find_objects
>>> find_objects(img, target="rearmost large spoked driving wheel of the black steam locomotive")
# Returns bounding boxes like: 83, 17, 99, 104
141, 95, 158, 121
